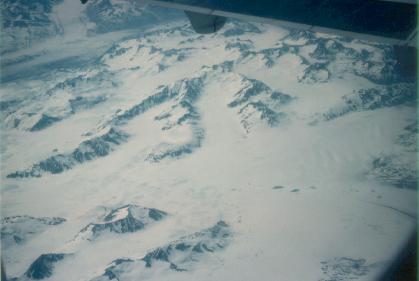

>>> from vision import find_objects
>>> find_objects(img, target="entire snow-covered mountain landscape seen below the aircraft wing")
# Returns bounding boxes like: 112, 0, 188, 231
0, 0, 417, 281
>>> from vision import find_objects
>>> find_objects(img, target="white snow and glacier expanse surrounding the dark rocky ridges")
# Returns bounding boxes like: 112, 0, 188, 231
1, 9, 417, 281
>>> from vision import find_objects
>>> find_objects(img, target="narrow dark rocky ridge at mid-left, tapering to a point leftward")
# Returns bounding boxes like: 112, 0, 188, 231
7, 128, 128, 178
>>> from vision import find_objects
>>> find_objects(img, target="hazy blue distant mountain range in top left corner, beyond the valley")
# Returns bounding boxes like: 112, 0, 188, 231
0, 0, 183, 54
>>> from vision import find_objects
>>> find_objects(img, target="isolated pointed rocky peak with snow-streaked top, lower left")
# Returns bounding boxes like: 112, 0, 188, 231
76, 205, 167, 240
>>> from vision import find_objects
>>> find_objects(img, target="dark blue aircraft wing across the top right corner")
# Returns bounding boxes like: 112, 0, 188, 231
148, 0, 417, 45
